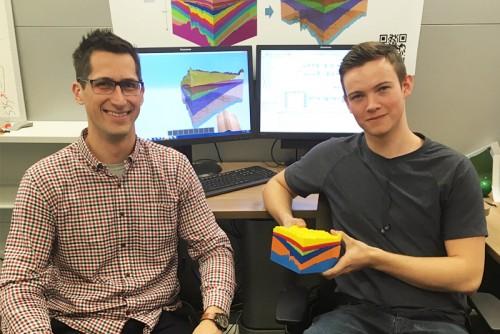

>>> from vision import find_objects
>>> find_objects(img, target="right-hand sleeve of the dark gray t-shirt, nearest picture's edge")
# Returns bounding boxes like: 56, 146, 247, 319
442, 158, 488, 240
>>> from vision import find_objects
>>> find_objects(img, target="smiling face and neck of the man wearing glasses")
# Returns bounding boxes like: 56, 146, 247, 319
72, 51, 144, 142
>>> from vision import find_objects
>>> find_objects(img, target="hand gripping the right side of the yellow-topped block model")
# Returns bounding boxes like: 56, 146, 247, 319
322, 230, 374, 279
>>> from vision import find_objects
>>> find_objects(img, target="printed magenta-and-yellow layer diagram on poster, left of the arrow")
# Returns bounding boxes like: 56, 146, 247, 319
172, 0, 257, 46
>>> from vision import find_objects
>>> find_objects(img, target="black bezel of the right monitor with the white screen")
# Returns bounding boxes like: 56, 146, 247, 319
255, 44, 361, 142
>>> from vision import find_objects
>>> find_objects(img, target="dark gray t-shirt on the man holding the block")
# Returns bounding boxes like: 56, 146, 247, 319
285, 134, 487, 313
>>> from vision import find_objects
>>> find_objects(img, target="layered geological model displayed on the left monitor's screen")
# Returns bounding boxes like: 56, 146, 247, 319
181, 69, 244, 128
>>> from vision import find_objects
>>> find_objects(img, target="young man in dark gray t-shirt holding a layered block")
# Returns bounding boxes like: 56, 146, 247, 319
264, 42, 486, 334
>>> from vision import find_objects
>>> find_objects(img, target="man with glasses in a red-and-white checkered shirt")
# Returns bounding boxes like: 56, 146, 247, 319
0, 30, 235, 334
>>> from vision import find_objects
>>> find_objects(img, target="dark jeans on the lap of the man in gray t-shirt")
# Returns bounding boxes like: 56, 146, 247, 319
304, 304, 468, 334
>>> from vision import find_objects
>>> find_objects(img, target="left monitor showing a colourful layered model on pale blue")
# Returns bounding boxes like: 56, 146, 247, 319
136, 47, 253, 143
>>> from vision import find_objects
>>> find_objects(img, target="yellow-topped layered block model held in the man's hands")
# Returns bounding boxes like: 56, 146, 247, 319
271, 226, 342, 274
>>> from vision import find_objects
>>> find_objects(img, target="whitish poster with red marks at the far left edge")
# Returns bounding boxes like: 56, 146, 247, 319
0, 0, 26, 121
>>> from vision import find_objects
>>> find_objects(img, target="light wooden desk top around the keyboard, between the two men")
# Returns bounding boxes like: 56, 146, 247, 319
207, 162, 318, 219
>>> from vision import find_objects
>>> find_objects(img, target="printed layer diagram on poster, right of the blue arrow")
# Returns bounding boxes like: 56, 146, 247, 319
281, 0, 368, 44
